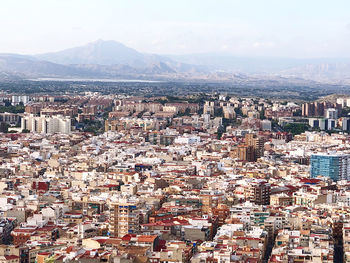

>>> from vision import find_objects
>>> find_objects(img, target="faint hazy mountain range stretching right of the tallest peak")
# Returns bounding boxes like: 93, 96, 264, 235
168, 53, 350, 84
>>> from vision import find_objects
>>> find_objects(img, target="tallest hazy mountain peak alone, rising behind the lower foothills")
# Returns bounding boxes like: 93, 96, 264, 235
35, 40, 204, 74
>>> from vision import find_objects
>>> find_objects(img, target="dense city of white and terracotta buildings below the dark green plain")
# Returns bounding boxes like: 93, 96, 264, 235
0, 92, 350, 263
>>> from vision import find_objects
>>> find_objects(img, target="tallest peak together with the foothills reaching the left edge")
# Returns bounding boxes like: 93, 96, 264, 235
0, 40, 205, 80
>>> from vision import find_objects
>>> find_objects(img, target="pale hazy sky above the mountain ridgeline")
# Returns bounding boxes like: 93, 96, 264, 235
0, 0, 350, 57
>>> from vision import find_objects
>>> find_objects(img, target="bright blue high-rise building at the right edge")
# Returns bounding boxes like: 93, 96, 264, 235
310, 154, 350, 181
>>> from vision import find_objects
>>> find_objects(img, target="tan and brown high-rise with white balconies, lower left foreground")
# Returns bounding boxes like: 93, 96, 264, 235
109, 200, 140, 237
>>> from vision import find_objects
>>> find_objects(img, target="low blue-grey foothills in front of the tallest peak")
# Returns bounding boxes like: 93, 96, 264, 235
0, 51, 204, 81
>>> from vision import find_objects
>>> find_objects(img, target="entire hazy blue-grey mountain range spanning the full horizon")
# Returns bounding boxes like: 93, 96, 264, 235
0, 40, 350, 84
